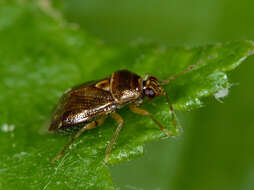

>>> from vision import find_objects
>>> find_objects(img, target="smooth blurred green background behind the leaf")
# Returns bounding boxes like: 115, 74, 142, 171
54, 0, 254, 190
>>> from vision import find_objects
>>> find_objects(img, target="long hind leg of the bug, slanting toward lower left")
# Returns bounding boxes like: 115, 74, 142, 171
51, 118, 105, 164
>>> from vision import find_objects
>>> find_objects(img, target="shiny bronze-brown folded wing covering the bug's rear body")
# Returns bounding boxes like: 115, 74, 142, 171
49, 82, 116, 131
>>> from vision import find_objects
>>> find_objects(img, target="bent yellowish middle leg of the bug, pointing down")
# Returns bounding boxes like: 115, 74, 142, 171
105, 113, 123, 163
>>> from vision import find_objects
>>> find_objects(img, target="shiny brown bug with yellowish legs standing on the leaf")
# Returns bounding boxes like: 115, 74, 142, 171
48, 66, 196, 163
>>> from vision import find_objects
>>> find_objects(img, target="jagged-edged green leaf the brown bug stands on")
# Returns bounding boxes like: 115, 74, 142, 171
0, 1, 254, 190
